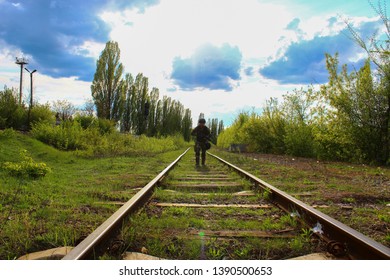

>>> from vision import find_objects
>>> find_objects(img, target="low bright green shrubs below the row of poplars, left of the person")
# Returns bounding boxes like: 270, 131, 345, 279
31, 118, 188, 156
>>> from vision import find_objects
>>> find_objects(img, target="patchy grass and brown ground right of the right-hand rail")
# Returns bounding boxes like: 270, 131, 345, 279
213, 150, 390, 246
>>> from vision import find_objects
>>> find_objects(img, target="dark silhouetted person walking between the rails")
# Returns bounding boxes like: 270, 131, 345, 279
191, 119, 210, 167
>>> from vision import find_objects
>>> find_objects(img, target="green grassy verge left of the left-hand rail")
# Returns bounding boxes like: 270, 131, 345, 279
0, 131, 189, 259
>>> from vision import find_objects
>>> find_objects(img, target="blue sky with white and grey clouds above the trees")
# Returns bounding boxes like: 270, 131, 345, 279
0, 0, 387, 125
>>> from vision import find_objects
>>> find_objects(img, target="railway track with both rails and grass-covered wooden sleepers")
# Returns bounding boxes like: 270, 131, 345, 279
63, 149, 390, 260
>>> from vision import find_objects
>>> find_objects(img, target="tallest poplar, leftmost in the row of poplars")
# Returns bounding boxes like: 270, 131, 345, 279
91, 41, 125, 121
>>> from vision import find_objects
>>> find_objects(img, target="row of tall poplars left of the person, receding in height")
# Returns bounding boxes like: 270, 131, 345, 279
91, 41, 192, 141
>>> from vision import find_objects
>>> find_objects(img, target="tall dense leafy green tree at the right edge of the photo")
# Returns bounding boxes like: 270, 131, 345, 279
322, 55, 390, 164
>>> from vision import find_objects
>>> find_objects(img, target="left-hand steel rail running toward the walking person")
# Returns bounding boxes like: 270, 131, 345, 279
62, 148, 190, 260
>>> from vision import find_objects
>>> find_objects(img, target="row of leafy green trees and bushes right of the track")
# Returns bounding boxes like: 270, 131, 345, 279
218, 55, 390, 164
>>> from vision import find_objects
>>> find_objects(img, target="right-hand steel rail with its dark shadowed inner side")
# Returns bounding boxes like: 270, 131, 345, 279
207, 152, 390, 260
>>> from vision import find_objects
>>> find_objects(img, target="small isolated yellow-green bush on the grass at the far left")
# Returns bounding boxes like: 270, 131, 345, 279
3, 150, 51, 179
